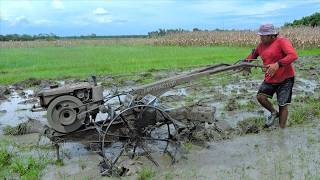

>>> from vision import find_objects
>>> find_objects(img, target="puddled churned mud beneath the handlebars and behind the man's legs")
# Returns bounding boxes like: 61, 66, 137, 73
161, 78, 319, 127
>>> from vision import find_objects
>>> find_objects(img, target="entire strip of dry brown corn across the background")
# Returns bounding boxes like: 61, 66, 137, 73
0, 27, 320, 49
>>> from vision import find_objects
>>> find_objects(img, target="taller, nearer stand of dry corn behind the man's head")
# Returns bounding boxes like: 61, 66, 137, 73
154, 27, 320, 49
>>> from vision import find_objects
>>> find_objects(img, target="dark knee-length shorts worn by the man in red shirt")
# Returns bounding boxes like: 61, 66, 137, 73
258, 77, 294, 106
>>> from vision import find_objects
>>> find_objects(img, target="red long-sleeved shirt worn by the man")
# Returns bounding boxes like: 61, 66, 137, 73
246, 36, 298, 83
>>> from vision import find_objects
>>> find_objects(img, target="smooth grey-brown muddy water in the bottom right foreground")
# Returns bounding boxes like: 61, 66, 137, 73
168, 126, 320, 179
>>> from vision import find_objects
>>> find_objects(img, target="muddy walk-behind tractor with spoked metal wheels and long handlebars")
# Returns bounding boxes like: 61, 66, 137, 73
33, 63, 258, 175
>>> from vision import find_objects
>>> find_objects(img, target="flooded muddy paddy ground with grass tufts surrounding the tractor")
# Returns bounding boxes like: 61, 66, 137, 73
0, 56, 320, 179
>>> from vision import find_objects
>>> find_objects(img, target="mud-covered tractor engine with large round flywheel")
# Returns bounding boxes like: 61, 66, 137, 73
37, 82, 103, 133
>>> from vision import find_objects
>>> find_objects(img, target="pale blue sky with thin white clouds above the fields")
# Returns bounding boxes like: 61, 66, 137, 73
0, 0, 320, 36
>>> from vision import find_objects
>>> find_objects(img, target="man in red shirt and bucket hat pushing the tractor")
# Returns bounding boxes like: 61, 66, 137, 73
245, 24, 298, 128
